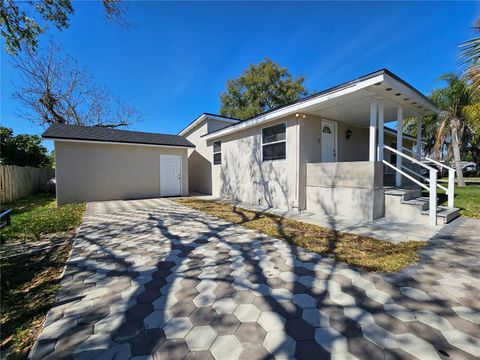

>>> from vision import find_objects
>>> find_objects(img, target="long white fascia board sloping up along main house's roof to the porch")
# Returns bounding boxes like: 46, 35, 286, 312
202, 73, 384, 140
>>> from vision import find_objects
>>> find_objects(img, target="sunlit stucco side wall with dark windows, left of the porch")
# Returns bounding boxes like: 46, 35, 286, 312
208, 119, 298, 209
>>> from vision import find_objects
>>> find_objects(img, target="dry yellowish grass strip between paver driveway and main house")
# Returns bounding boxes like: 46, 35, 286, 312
174, 198, 426, 272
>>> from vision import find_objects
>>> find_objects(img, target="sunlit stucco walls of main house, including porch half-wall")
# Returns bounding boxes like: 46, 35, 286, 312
207, 115, 418, 219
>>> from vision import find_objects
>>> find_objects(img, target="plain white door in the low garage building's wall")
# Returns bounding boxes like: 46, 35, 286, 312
160, 155, 182, 196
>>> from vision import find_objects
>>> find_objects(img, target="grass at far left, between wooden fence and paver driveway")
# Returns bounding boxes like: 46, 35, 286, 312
0, 195, 85, 359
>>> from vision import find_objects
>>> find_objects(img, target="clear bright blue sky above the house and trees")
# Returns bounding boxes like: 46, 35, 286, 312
1, 2, 480, 149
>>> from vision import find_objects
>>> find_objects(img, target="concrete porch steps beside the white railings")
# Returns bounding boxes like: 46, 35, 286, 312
385, 187, 460, 224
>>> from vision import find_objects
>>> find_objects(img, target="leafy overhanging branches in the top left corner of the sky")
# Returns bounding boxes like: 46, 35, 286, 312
0, 0, 127, 55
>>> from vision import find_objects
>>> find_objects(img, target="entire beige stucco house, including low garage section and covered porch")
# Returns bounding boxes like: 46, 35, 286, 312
44, 69, 458, 225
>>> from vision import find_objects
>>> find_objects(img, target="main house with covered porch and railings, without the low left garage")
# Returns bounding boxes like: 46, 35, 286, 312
183, 69, 458, 224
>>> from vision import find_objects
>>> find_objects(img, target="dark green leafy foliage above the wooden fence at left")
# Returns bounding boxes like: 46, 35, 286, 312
0, 126, 52, 167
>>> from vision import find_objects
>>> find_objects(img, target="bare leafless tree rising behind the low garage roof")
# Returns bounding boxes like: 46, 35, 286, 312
13, 40, 141, 128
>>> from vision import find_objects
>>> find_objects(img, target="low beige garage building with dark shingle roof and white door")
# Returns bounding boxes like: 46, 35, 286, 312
43, 124, 194, 204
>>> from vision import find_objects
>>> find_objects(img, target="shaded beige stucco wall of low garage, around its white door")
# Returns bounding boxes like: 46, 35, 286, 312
55, 141, 188, 204
